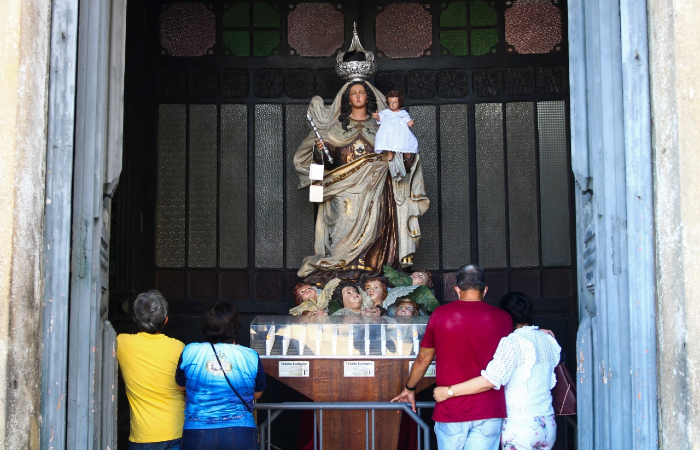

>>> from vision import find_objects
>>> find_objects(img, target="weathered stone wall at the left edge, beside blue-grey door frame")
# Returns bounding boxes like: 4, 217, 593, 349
0, 0, 51, 449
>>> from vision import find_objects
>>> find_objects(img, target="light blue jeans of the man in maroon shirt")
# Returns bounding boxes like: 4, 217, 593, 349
435, 419, 503, 450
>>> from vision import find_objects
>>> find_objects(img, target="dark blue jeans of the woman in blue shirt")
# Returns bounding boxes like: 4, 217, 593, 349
180, 427, 258, 450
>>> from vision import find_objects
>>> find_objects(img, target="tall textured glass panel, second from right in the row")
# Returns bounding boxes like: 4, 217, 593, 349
506, 102, 540, 267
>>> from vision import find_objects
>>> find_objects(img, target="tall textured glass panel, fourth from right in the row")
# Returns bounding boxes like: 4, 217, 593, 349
442, 104, 471, 269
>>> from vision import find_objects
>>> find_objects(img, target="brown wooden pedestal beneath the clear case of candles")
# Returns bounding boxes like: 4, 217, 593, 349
262, 358, 435, 450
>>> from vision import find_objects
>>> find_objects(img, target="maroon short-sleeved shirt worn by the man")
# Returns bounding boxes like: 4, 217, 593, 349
421, 301, 512, 422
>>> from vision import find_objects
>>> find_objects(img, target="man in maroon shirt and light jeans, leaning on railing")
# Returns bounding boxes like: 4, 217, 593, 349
392, 265, 513, 450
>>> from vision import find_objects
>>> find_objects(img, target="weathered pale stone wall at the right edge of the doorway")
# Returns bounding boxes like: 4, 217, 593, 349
648, 0, 700, 450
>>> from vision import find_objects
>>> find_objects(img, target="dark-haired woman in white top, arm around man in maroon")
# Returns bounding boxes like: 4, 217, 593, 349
434, 292, 561, 450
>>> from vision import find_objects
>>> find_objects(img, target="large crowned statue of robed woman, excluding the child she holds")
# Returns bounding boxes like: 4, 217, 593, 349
294, 25, 430, 286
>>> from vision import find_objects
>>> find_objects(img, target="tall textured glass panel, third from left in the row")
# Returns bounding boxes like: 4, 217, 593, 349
219, 105, 248, 268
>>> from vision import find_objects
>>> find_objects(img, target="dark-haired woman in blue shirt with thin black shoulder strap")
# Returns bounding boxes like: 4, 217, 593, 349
175, 303, 265, 450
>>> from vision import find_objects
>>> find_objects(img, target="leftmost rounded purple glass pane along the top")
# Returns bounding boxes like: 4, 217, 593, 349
160, 3, 216, 56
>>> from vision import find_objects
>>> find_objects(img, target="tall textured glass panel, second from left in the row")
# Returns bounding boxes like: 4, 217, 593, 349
187, 105, 217, 267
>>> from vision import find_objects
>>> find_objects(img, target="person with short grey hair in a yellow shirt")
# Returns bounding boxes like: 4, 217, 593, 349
117, 291, 185, 449
